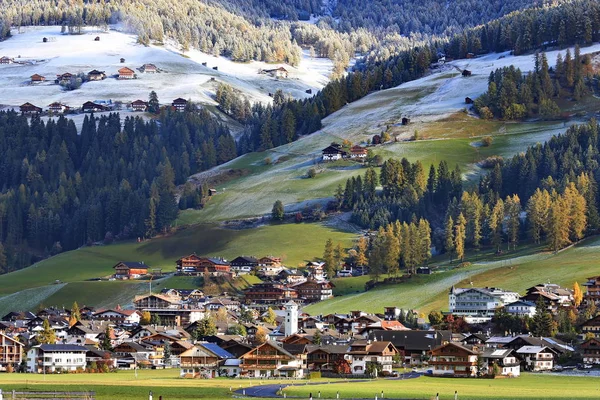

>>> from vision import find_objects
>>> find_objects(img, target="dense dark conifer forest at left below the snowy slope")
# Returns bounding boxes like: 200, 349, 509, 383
0, 105, 237, 272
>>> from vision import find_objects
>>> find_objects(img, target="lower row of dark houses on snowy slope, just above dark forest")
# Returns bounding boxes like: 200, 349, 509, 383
19, 98, 188, 115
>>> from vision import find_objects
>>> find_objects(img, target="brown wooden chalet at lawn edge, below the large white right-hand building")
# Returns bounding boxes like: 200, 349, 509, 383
429, 342, 480, 377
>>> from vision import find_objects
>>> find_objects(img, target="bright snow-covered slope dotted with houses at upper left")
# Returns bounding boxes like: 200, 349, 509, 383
0, 27, 331, 107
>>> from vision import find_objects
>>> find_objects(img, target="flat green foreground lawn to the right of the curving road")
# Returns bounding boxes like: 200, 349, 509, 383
285, 374, 600, 400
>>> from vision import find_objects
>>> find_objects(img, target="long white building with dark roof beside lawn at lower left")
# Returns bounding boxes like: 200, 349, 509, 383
27, 344, 87, 373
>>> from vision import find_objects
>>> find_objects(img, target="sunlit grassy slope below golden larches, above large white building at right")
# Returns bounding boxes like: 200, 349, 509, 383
304, 237, 600, 314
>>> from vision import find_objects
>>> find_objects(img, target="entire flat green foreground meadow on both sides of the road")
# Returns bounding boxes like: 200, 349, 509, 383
0, 369, 600, 400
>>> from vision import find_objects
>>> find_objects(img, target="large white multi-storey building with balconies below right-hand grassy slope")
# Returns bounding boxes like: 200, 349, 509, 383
448, 286, 519, 317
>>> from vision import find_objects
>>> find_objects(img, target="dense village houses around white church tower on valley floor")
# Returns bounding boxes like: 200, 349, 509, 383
0, 298, 600, 378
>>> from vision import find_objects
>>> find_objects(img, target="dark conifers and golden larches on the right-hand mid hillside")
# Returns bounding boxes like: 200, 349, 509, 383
326, 121, 600, 278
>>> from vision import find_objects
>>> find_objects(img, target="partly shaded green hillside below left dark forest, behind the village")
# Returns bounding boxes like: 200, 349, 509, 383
0, 223, 356, 311
